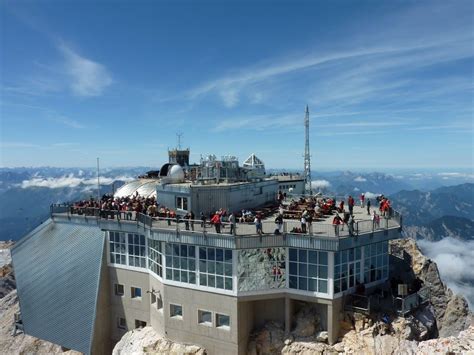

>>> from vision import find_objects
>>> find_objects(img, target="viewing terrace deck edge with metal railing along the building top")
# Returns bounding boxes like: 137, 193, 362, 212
51, 205, 402, 250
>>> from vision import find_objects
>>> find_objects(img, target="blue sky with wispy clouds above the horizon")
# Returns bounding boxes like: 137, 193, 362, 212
0, 0, 474, 170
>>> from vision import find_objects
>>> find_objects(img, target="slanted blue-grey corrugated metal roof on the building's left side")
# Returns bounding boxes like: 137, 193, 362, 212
12, 222, 104, 354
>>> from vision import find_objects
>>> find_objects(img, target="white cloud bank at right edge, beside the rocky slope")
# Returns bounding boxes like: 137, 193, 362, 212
418, 238, 474, 308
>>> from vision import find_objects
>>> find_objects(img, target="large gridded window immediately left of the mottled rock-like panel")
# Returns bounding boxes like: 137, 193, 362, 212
199, 247, 232, 290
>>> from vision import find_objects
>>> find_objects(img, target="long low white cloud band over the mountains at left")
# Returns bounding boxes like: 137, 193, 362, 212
20, 174, 134, 189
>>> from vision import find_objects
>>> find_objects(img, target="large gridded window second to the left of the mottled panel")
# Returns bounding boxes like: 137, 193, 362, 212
165, 243, 196, 284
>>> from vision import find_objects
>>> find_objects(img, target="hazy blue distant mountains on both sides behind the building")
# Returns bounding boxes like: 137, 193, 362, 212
0, 167, 474, 240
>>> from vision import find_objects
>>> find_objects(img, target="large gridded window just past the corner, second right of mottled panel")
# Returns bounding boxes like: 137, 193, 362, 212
334, 248, 361, 293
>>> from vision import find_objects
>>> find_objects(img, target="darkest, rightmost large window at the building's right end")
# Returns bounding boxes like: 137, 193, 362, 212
364, 242, 388, 283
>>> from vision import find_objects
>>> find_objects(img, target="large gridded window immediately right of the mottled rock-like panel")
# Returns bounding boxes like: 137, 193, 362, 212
288, 248, 328, 293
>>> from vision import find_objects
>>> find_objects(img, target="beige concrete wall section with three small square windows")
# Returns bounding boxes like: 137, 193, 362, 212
164, 285, 238, 355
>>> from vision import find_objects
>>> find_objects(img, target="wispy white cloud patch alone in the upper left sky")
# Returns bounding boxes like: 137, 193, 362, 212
58, 44, 113, 96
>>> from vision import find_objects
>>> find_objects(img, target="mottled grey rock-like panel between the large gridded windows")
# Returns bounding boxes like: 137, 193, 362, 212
237, 248, 286, 291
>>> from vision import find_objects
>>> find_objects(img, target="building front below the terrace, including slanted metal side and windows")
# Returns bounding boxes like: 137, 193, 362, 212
12, 209, 401, 354
